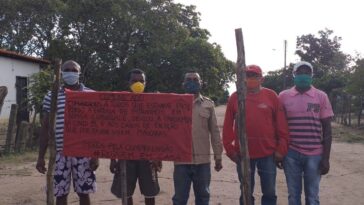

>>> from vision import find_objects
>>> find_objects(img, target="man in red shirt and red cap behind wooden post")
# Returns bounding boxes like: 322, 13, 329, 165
223, 65, 289, 205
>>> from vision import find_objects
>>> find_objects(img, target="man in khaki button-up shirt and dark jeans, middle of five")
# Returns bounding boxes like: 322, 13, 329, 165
172, 72, 222, 205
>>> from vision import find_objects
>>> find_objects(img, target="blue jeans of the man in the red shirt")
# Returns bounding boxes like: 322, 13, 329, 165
237, 155, 277, 205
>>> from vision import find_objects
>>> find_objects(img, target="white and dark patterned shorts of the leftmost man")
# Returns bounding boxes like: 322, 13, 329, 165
53, 152, 96, 197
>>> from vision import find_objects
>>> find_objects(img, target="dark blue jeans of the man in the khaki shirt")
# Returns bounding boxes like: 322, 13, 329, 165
172, 163, 211, 205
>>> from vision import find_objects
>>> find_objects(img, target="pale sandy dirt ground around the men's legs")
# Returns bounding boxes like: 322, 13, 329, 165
0, 106, 364, 205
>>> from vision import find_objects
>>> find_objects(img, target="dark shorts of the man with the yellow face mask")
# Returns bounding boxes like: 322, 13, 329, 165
111, 160, 160, 198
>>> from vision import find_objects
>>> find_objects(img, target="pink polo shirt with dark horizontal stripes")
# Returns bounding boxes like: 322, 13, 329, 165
279, 87, 334, 155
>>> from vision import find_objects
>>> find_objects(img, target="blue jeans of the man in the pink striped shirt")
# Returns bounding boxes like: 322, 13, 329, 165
283, 149, 321, 205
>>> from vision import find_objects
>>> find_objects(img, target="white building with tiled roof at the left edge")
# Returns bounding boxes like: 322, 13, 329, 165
0, 49, 50, 121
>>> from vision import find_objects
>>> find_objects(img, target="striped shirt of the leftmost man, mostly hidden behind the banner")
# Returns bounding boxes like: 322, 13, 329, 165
43, 84, 93, 151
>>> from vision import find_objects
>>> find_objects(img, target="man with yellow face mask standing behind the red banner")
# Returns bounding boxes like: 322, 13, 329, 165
110, 69, 162, 205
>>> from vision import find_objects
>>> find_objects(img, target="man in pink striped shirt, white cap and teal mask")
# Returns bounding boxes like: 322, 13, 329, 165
279, 61, 334, 205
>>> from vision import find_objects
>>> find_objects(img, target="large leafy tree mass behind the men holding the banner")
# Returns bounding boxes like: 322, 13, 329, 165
0, 0, 233, 102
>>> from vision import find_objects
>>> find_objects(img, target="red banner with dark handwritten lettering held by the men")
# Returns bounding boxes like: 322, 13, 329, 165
63, 91, 193, 162
